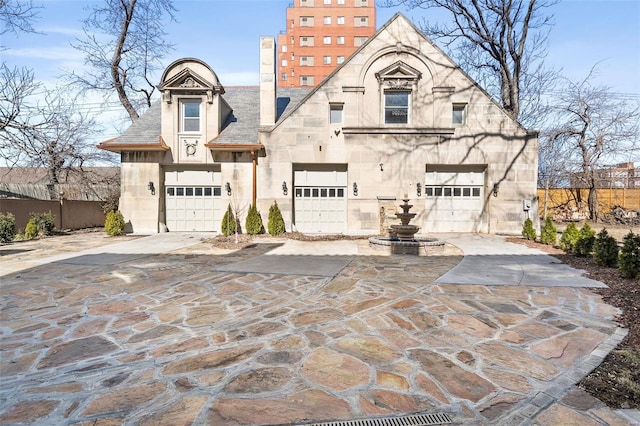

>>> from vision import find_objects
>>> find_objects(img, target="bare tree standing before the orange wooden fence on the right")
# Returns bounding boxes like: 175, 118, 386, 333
540, 70, 640, 222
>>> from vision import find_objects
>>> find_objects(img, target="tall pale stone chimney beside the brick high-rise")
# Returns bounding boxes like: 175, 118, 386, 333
260, 37, 276, 126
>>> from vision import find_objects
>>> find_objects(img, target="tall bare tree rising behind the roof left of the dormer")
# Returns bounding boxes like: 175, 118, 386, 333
70, 0, 175, 121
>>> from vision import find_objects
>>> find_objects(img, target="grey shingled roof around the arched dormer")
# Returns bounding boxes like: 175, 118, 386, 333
98, 86, 310, 151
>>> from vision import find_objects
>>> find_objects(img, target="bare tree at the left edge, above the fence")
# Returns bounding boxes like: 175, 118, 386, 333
0, 64, 114, 184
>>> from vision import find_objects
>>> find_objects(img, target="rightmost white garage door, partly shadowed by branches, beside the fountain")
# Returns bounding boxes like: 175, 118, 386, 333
423, 171, 484, 233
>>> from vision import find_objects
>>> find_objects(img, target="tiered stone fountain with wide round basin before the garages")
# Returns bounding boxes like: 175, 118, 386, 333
369, 195, 444, 256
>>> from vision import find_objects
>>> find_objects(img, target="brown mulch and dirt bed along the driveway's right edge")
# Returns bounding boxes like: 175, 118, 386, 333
511, 221, 640, 408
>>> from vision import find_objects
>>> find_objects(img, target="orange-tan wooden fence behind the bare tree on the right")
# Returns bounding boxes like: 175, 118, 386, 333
538, 188, 640, 220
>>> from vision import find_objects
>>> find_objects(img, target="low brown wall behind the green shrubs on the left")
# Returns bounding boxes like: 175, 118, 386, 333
0, 198, 106, 232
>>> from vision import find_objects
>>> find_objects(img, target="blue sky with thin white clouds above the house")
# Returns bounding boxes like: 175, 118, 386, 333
0, 0, 640, 136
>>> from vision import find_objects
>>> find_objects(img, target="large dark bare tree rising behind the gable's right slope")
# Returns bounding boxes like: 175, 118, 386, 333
383, 0, 558, 122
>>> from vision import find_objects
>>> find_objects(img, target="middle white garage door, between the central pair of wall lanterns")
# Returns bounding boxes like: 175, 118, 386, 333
294, 170, 347, 234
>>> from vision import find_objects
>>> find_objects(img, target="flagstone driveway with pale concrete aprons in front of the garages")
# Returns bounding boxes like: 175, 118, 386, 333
0, 234, 640, 426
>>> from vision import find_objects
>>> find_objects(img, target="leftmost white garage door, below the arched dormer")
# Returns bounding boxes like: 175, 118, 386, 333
166, 186, 222, 232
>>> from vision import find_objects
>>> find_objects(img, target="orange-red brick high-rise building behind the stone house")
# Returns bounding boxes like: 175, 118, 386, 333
278, 0, 376, 87
